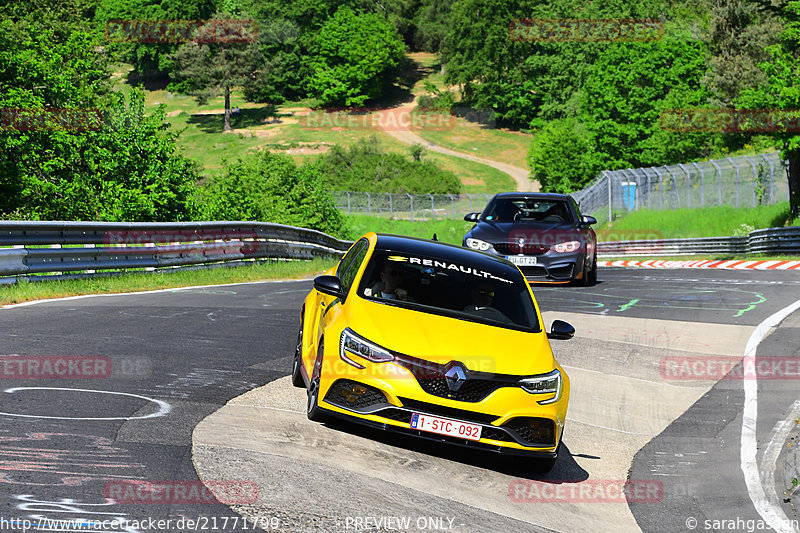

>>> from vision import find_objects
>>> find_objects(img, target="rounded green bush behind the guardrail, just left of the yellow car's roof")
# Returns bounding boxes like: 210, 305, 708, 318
197, 151, 347, 236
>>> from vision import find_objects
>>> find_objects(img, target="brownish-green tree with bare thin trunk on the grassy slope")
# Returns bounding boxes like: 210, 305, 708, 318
170, 15, 266, 131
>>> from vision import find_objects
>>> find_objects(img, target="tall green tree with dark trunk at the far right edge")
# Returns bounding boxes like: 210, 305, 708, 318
737, 0, 800, 221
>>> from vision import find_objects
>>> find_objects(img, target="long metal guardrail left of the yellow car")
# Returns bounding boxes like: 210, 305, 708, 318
0, 221, 351, 283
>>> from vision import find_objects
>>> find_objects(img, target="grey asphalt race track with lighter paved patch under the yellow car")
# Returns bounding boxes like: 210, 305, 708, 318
0, 268, 800, 532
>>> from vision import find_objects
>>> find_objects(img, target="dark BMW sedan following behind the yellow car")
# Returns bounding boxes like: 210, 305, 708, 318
463, 192, 597, 285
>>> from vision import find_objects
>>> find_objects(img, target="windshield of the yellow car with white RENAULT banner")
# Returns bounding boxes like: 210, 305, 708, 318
358, 250, 539, 331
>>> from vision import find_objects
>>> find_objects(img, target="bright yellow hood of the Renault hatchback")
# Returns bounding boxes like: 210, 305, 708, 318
349, 298, 555, 375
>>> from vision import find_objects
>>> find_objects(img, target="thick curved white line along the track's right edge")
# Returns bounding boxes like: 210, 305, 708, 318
741, 300, 800, 533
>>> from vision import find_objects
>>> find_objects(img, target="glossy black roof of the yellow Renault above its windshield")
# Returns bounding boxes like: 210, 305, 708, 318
375, 233, 522, 277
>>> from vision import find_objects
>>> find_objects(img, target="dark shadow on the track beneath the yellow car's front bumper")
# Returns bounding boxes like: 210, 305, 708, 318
318, 419, 589, 484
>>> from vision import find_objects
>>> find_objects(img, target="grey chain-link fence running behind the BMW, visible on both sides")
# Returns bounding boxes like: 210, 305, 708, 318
333, 152, 789, 223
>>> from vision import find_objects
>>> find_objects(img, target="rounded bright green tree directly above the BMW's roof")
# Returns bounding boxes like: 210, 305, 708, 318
528, 118, 602, 194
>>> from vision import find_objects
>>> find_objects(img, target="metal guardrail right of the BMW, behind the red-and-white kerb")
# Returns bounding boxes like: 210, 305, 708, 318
597, 226, 800, 257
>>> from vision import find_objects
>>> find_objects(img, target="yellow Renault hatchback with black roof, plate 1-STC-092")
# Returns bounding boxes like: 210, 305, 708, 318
292, 233, 575, 472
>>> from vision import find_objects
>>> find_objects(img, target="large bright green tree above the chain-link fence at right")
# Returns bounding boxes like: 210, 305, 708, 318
580, 35, 714, 169
